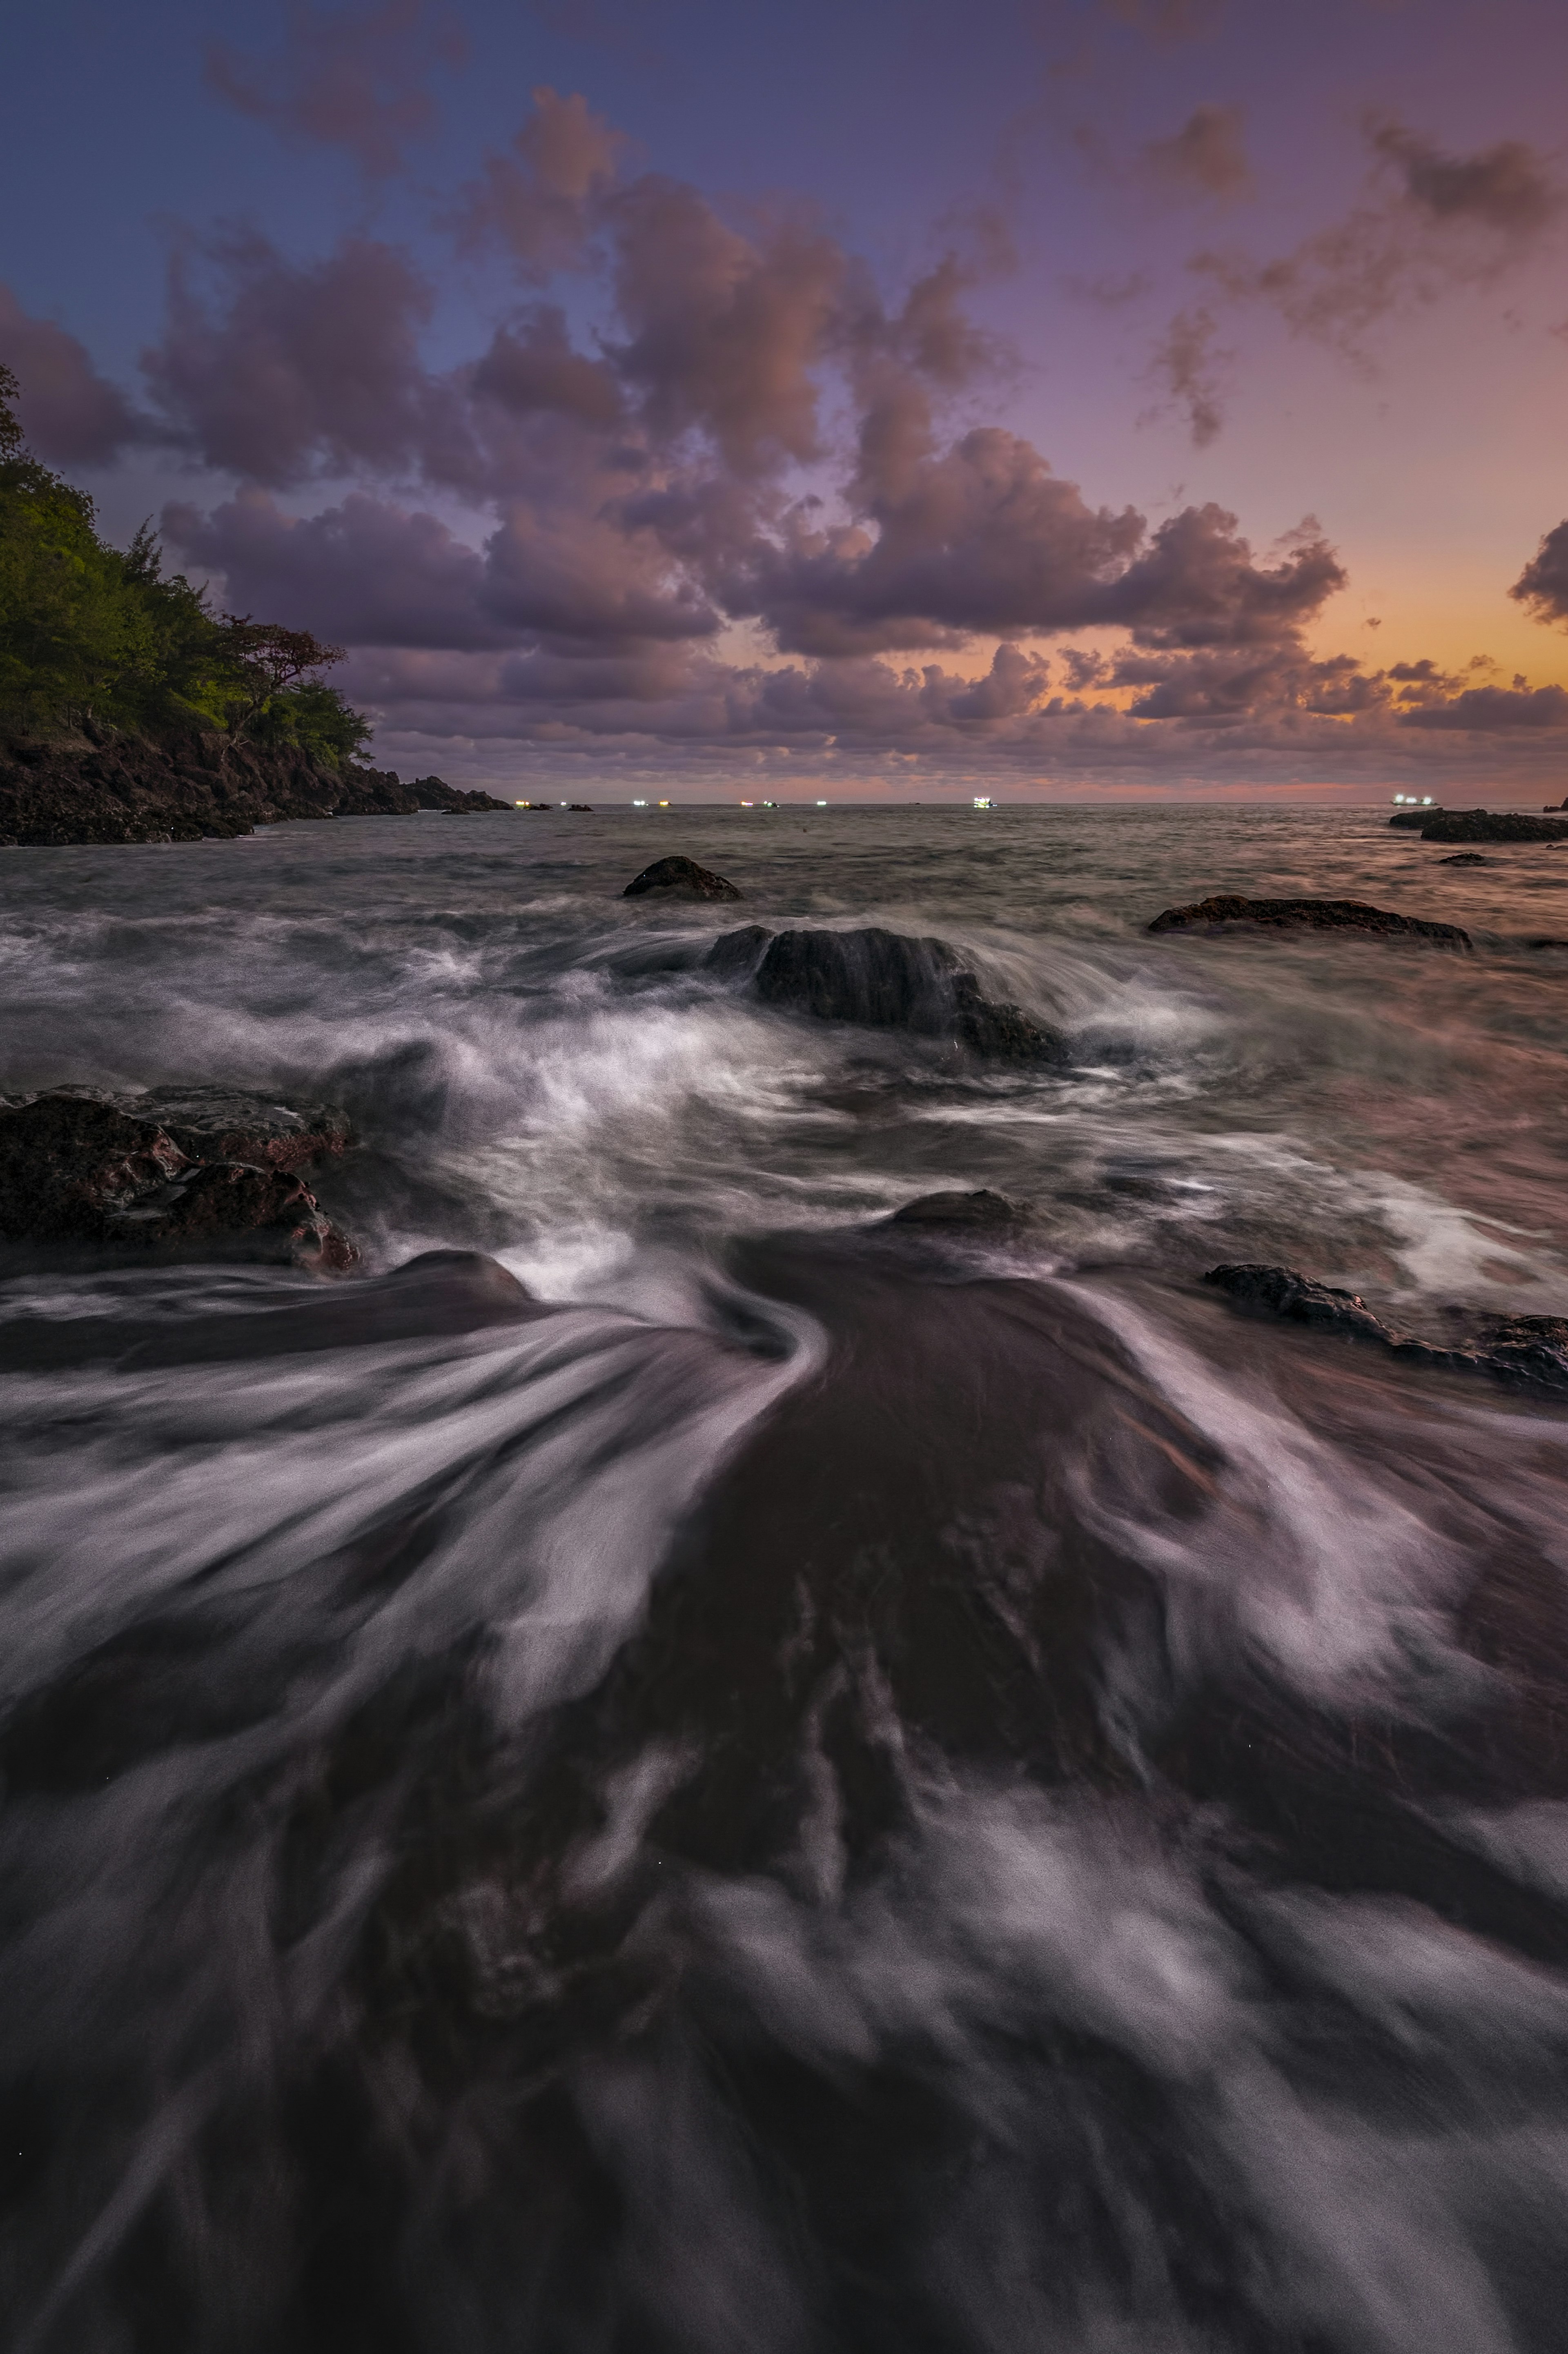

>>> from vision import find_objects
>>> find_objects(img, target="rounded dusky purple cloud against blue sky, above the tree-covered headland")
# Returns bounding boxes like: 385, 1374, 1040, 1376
141, 233, 431, 485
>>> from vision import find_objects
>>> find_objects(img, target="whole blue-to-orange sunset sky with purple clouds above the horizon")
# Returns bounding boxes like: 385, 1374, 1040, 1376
0, 0, 1568, 807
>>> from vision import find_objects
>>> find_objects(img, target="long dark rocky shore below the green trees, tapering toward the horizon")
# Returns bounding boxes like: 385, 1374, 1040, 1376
0, 730, 511, 847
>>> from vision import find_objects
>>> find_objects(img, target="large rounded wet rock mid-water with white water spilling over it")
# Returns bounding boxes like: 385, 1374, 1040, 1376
730, 927, 1067, 1064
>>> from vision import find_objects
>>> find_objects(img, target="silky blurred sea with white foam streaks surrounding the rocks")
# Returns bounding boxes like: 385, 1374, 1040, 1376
0, 805, 1568, 2354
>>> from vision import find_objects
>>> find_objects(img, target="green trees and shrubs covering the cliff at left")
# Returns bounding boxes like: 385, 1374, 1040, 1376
0, 367, 370, 767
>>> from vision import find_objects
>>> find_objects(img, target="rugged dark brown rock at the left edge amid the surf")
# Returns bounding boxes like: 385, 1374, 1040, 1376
0, 1090, 358, 1274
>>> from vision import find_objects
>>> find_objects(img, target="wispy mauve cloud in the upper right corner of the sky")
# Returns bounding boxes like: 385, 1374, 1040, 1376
1191, 118, 1563, 356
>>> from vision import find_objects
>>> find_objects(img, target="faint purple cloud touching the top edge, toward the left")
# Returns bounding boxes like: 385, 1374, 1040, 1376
203, 0, 466, 179
